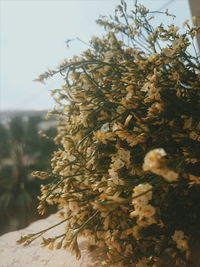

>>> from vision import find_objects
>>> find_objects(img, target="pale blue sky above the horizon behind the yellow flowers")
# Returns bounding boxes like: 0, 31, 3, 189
0, 0, 190, 111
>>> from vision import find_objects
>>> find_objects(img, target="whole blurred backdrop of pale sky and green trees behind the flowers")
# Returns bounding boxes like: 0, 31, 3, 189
0, 0, 200, 234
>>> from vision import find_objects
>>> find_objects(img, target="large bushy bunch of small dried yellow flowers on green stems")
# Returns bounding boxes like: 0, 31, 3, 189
19, 1, 200, 267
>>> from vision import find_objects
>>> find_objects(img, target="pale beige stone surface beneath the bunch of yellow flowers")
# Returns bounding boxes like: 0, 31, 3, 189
0, 214, 104, 267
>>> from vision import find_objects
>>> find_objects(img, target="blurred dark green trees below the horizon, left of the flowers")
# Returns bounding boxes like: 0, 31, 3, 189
0, 116, 56, 234
